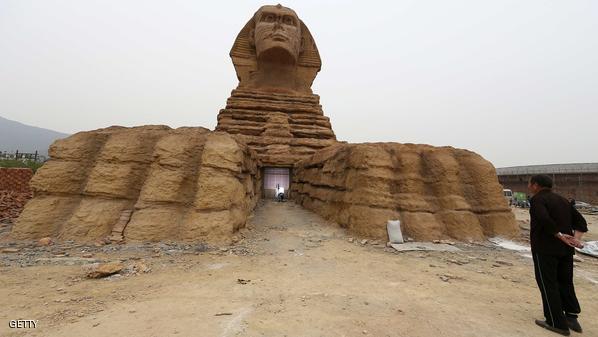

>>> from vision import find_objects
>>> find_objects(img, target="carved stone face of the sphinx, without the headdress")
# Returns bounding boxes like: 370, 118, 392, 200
254, 6, 301, 63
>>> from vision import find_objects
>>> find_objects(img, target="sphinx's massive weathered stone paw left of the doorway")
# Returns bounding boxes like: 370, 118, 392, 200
12, 126, 259, 242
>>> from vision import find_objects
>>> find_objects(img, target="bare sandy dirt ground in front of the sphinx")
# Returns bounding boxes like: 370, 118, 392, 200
0, 202, 598, 337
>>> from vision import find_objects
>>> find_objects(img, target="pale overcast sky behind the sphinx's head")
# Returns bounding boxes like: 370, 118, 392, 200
0, 0, 598, 167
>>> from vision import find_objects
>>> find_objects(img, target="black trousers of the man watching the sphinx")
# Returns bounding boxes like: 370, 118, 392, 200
533, 253, 581, 330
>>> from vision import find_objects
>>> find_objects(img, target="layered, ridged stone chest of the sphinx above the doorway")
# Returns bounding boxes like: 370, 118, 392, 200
216, 89, 337, 166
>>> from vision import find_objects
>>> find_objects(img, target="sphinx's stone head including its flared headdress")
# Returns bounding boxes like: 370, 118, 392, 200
230, 5, 322, 94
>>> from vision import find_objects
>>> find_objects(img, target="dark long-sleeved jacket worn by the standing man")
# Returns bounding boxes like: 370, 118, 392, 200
529, 189, 588, 256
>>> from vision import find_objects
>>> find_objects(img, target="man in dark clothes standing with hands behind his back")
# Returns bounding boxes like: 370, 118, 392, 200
528, 175, 588, 336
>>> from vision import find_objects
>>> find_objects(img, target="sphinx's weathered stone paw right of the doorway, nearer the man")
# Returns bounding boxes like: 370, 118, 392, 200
291, 143, 518, 240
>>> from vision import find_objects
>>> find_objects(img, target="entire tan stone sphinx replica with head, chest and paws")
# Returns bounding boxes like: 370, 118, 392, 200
11, 5, 518, 243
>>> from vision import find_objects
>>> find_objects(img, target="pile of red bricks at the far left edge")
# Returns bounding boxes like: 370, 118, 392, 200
0, 167, 33, 223
